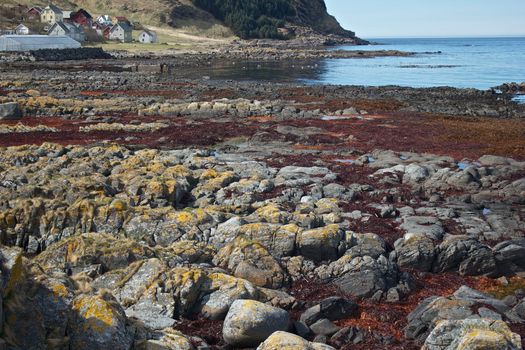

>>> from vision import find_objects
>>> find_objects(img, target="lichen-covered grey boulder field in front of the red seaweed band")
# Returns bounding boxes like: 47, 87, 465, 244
0, 143, 525, 350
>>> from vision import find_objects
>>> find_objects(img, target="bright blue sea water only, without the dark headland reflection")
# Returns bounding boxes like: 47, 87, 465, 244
309, 38, 525, 89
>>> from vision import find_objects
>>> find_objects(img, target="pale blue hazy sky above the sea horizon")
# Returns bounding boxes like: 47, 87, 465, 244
326, 0, 525, 38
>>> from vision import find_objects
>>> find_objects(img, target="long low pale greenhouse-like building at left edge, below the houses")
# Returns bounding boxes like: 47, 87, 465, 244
0, 35, 80, 52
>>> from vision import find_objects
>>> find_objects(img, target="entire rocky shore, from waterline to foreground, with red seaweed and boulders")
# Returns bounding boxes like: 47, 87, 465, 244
0, 58, 525, 350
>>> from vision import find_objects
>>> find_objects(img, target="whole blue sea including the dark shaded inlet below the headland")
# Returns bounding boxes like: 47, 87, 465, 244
183, 37, 525, 90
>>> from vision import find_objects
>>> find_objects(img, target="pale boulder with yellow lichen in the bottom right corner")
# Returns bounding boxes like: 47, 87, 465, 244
422, 319, 521, 350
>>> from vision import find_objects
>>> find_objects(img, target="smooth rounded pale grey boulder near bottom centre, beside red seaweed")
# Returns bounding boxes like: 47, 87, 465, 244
222, 300, 290, 347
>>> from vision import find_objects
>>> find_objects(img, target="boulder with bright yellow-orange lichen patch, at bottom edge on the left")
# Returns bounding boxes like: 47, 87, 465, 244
68, 292, 133, 350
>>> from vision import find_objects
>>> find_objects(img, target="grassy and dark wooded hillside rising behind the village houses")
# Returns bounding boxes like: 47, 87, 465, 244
0, 0, 360, 39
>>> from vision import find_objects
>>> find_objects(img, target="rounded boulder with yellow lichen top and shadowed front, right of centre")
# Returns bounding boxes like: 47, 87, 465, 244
297, 224, 343, 261
